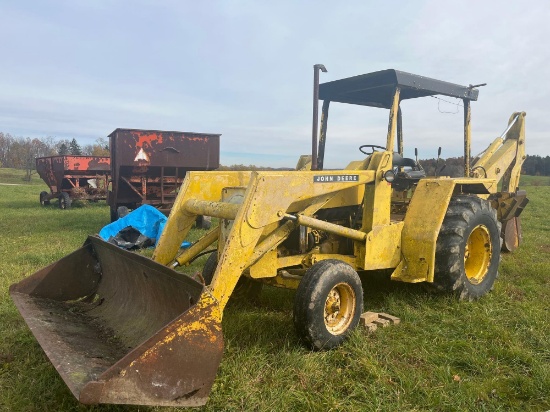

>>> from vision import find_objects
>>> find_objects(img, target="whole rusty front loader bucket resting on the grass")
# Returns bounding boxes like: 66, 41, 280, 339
10, 236, 223, 406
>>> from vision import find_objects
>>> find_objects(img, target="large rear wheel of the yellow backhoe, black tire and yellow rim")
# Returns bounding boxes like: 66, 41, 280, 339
433, 195, 501, 300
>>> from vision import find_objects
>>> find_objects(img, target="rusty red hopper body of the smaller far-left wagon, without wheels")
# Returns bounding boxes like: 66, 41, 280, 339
36, 155, 111, 199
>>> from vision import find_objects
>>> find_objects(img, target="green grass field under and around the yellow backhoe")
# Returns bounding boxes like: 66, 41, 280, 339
0, 169, 550, 411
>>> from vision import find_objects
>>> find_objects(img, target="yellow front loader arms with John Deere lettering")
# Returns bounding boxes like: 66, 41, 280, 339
153, 170, 375, 314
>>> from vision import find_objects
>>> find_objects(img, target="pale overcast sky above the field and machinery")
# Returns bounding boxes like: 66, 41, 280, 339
0, 0, 550, 167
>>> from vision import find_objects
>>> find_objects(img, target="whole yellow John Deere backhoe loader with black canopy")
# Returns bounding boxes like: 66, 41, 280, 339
10, 65, 527, 406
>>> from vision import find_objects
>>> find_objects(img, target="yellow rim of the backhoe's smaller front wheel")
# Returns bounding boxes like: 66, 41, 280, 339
325, 283, 355, 335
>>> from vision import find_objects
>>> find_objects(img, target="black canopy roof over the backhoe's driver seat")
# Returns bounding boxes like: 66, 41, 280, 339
319, 69, 479, 109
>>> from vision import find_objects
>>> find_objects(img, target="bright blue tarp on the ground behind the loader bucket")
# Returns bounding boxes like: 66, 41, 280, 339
99, 205, 190, 247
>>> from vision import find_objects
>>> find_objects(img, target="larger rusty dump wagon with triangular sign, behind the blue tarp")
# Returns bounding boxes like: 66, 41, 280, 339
108, 129, 220, 221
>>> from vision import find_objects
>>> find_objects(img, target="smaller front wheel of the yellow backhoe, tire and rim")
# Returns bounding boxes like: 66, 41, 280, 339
294, 259, 363, 350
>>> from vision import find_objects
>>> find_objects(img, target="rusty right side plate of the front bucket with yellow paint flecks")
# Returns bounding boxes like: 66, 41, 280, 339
80, 293, 223, 406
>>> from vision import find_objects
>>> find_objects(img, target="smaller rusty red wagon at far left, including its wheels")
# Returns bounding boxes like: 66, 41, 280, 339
36, 155, 111, 209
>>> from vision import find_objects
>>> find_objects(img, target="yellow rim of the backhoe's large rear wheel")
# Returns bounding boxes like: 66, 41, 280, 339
464, 225, 493, 283
